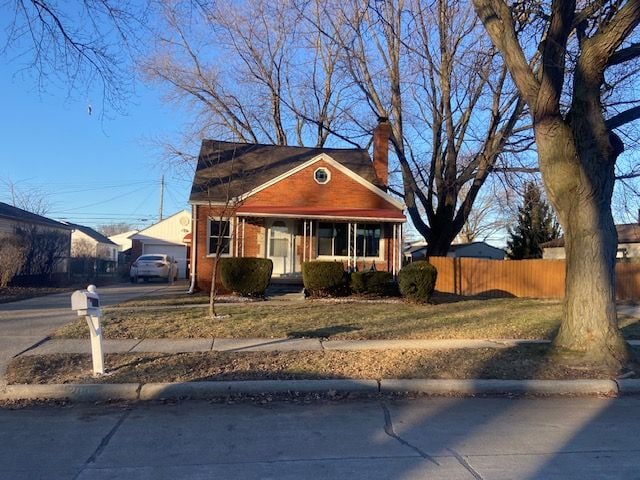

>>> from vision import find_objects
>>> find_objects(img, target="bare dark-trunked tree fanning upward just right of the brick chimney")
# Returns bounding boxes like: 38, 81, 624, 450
308, 0, 527, 255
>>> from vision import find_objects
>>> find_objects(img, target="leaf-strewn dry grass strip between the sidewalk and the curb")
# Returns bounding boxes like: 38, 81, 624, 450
7, 345, 639, 384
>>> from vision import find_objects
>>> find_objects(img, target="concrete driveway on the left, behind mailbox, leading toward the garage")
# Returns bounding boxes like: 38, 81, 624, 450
0, 282, 187, 387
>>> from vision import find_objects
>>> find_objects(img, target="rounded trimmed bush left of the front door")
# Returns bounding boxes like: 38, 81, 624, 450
220, 257, 273, 297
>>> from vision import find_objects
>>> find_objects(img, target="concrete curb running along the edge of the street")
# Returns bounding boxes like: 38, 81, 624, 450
0, 379, 624, 402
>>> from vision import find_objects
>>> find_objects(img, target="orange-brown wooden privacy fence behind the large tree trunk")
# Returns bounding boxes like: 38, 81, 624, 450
429, 257, 640, 300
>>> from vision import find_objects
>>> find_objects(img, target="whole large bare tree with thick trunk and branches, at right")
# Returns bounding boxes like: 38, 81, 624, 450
473, 0, 640, 367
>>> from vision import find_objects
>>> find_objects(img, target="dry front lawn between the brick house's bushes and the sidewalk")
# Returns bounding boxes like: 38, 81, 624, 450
54, 298, 564, 340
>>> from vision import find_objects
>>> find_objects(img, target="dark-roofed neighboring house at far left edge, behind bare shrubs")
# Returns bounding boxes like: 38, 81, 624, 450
0, 202, 72, 274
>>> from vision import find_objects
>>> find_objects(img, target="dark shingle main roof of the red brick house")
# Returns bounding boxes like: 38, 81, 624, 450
189, 140, 382, 202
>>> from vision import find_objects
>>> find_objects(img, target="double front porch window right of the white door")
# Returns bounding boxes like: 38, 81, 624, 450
318, 222, 382, 257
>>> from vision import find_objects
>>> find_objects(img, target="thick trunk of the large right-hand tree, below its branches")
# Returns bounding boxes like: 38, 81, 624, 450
536, 119, 629, 368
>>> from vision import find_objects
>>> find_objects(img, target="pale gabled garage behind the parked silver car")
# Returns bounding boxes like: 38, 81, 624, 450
129, 210, 191, 278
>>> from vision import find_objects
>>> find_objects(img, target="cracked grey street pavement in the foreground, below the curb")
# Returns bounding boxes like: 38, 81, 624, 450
0, 397, 640, 480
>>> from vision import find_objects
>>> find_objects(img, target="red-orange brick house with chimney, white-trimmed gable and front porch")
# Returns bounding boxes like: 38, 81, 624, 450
189, 122, 406, 288
